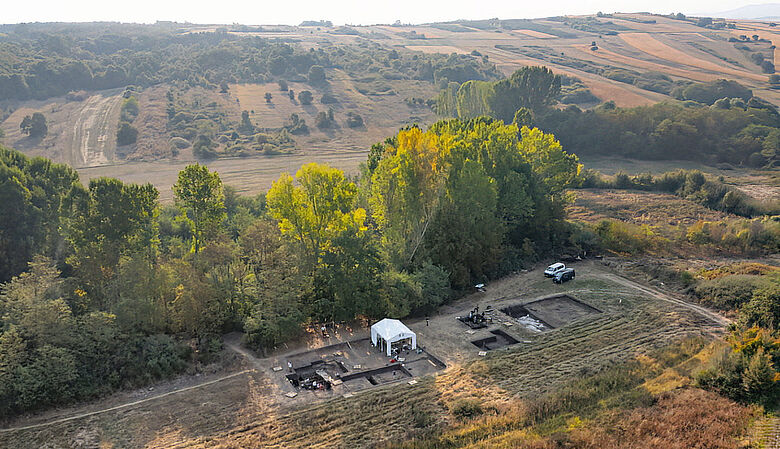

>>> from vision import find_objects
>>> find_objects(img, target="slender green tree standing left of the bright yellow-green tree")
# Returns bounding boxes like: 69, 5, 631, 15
173, 164, 225, 253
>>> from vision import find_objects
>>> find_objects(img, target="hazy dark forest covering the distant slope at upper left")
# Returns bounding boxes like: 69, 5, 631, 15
0, 23, 497, 100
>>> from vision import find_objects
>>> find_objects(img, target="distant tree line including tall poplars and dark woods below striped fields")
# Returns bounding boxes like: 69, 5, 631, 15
436, 67, 780, 168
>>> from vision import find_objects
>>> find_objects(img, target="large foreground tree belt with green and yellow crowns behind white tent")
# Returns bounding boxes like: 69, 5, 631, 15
0, 118, 581, 416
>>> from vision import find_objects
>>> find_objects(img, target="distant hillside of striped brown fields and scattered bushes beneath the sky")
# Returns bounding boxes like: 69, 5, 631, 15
0, 14, 780, 197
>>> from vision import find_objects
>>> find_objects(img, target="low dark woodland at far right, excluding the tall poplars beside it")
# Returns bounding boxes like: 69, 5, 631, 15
535, 99, 780, 167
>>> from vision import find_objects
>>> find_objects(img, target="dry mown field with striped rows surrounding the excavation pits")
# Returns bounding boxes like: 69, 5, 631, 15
0, 262, 725, 448
